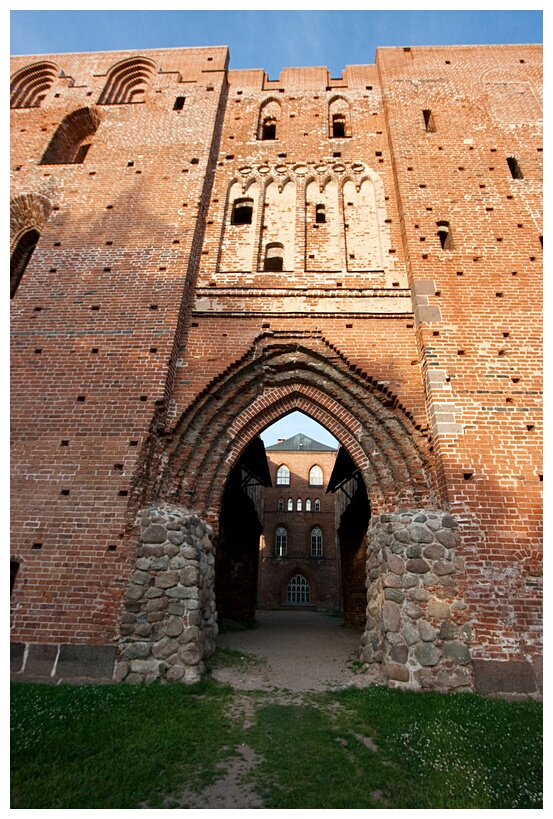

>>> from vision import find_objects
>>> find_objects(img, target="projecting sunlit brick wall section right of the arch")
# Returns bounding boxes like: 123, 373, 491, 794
377, 46, 543, 672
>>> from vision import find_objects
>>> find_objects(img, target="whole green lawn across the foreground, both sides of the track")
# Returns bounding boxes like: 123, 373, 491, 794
12, 680, 542, 809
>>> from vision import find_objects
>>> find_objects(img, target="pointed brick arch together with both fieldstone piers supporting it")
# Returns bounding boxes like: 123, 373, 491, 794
123, 332, 472, 690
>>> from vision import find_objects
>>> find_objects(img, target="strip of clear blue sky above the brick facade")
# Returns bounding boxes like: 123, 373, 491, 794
10, 8, 542, 79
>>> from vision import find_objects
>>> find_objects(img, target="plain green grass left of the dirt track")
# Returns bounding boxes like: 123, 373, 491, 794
8, 681, 236, 809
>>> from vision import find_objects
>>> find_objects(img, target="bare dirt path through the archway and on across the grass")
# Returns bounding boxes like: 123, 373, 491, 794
151, 610, 382, 810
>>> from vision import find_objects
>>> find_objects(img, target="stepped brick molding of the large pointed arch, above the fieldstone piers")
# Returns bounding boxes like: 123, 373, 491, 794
154, 336, 435, 520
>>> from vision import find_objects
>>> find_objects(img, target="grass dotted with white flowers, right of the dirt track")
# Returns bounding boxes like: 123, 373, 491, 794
240, 686, 542, 809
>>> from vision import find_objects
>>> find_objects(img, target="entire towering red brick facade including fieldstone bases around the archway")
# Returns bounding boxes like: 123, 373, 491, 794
10, 45, 543, 694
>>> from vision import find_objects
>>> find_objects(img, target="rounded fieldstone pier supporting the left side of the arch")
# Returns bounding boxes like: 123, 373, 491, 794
116, 505, 217, 683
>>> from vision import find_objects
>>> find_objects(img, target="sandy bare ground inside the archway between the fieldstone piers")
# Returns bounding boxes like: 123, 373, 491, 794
209, 611, 381, 691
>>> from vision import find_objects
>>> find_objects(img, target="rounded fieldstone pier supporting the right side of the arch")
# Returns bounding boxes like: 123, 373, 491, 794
361, 510, 473, 691
